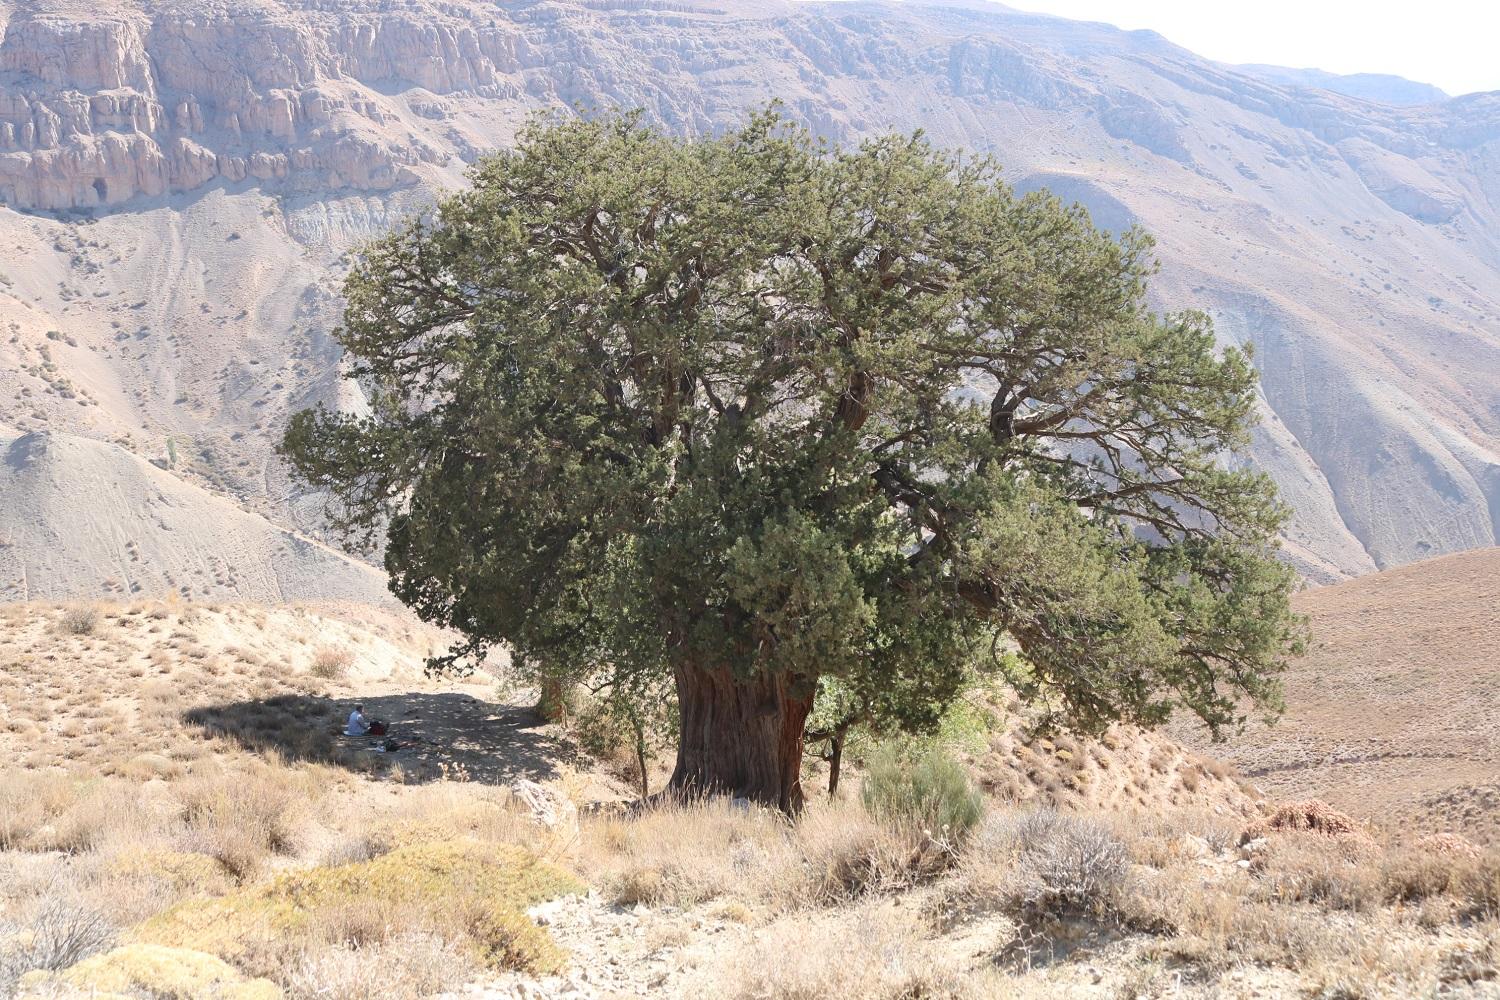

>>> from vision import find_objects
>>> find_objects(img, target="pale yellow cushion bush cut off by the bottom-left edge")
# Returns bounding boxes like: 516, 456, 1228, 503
20, 943, 282, 1000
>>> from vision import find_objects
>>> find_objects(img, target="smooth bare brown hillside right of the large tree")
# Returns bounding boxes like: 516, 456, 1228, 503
1182, 549, 1500, 843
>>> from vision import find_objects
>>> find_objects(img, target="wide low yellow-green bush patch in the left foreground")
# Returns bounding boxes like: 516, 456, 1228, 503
137, 840, 584, 972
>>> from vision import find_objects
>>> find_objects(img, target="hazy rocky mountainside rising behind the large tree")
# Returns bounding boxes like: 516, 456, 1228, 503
0, 0, 1500, 590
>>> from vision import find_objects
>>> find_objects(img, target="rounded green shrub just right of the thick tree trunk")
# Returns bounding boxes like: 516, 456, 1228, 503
861, 744, 984, 841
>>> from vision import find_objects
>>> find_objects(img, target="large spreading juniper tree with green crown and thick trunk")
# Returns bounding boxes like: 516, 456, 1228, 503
284, 112, 1299, 811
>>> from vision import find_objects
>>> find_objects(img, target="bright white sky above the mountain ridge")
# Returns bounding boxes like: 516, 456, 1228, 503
1002, 0, 1500, 97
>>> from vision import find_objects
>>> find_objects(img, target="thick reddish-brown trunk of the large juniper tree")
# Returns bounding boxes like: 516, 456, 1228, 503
668, 666, 818, 814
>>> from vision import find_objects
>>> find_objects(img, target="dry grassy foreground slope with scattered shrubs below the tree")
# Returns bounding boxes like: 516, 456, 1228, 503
0, 603, 1500, 1000
